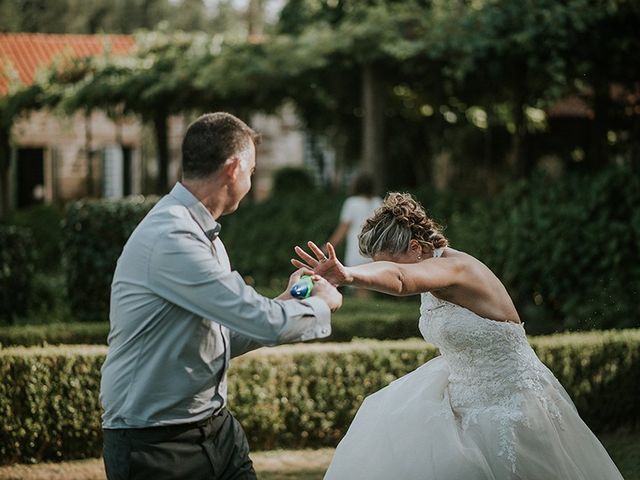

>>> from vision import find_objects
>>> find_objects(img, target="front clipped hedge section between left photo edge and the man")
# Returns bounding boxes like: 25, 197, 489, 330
0, 347, 105, 463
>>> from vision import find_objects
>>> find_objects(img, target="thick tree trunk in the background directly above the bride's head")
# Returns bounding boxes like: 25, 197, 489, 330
361, 65, 386, 191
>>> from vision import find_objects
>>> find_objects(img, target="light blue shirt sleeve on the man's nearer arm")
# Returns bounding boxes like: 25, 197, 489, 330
147, 231, 331, 344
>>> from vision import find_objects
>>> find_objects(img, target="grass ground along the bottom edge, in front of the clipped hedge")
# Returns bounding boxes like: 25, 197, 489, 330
0, 432, 640, 480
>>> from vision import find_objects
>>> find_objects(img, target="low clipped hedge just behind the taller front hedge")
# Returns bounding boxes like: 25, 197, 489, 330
0, 298, 420, 347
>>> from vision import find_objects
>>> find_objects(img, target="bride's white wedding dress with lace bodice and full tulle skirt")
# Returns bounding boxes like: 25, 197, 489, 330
324, 253, 622, 480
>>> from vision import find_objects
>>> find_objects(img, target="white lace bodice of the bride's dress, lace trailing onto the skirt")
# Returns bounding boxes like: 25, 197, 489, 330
419, 251, 561, 472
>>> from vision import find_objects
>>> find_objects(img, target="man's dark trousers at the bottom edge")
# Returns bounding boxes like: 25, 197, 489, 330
103, 409, 257, 480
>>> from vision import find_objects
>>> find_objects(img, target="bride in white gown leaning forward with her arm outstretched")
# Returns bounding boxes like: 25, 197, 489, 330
292, 193, 622, 480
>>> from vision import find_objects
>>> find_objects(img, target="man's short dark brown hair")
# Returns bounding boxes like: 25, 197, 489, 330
182, 112, 260, 179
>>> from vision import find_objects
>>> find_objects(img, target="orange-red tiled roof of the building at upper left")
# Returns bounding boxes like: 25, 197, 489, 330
0, 33, 135, 95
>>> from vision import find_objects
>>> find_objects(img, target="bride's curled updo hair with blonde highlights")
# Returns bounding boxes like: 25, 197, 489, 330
358, 192, 449, 258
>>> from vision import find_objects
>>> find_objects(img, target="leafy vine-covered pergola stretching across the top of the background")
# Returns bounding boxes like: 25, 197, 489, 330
0, 0, 640, 213
